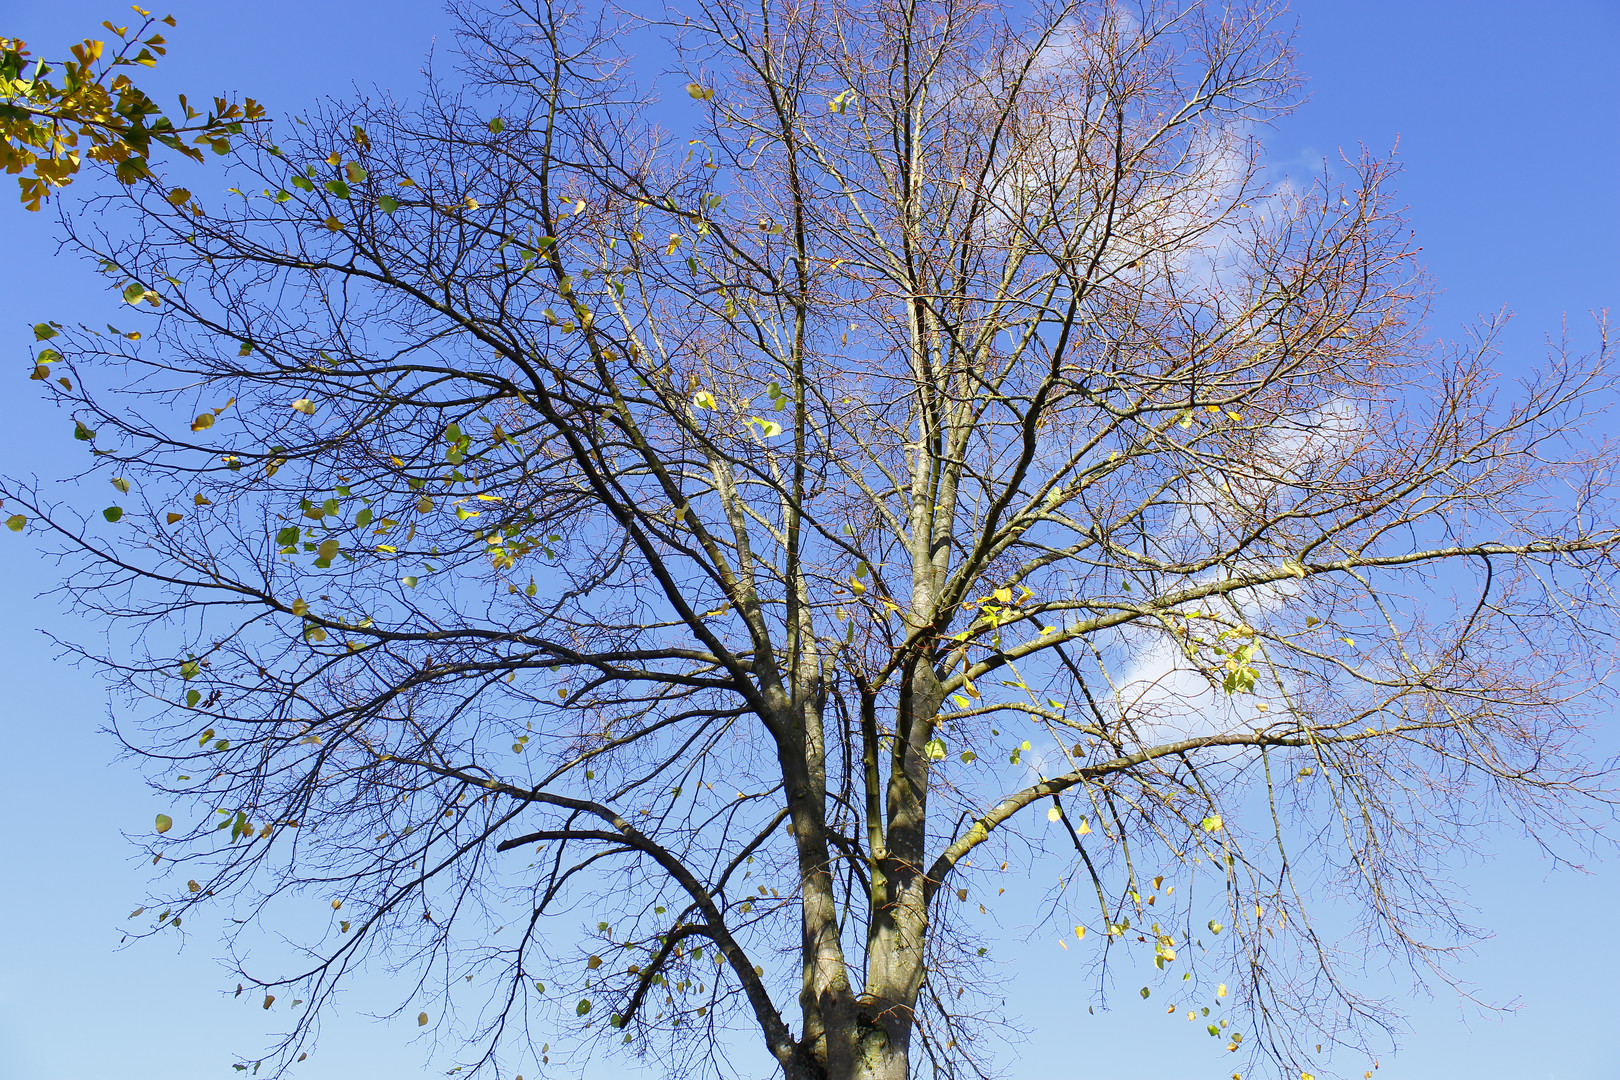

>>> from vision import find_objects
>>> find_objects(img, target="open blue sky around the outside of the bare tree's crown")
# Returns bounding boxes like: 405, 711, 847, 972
0, 0, 1620, 1080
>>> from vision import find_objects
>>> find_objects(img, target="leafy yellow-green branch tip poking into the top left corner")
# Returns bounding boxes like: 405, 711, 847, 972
0, 8, 264, 210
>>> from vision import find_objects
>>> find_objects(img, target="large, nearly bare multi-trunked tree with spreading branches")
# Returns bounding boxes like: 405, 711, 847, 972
0, 0, 1617, 1080
